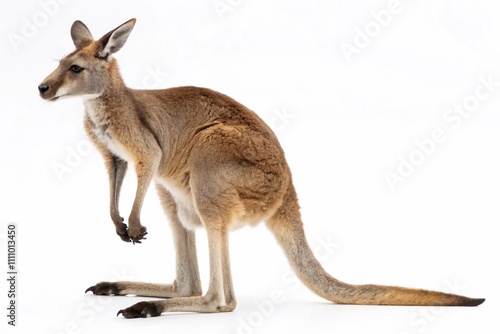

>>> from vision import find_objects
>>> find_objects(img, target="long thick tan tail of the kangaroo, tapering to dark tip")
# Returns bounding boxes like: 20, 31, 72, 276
266, 189, 484, 306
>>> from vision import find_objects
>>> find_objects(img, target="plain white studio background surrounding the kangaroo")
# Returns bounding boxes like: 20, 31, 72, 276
0, 0, 500, 334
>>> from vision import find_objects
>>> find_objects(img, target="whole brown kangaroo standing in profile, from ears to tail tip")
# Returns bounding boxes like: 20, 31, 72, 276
38, 19, 484, 318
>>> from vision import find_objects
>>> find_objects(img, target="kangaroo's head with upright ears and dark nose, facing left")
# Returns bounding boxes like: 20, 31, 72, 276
38, 19, 136, 101
